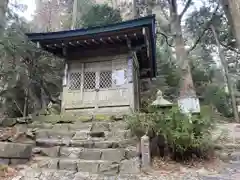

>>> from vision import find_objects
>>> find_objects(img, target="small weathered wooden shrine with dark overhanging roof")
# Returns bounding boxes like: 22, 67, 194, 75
26, 16, 156, 113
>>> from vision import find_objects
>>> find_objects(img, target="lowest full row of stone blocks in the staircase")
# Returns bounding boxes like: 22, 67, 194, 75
33, 157, 140, 175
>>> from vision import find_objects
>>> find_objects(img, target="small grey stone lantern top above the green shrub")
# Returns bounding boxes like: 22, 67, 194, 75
151, 90, 173, 110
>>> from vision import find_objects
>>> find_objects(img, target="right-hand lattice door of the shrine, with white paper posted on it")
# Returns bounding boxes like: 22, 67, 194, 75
98, 58, 130, 107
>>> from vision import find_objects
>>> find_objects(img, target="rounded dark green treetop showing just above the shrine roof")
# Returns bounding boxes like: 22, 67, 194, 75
81, 4, 122, 27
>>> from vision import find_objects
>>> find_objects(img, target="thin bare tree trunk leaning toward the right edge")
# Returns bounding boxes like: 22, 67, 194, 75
211, 25, 239, 122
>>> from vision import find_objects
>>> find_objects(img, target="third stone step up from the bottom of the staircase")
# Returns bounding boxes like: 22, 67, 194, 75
36, 138, 134, 149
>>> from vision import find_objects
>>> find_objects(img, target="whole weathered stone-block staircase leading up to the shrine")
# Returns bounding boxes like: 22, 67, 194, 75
20, 118, 140, 179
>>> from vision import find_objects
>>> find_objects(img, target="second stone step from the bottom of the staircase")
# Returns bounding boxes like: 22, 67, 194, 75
33, 146, 138, 162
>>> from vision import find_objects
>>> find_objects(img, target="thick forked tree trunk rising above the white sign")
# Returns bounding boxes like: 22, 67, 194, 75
156, 0, 201, 112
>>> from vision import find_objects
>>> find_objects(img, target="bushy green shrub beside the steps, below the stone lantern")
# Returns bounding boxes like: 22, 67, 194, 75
127, 107, 214, 160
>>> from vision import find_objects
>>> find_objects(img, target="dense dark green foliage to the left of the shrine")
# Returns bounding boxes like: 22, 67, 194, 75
0, 8, 63, 117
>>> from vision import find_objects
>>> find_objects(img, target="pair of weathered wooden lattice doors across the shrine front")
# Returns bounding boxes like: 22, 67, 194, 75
64, 59, 130, 108
